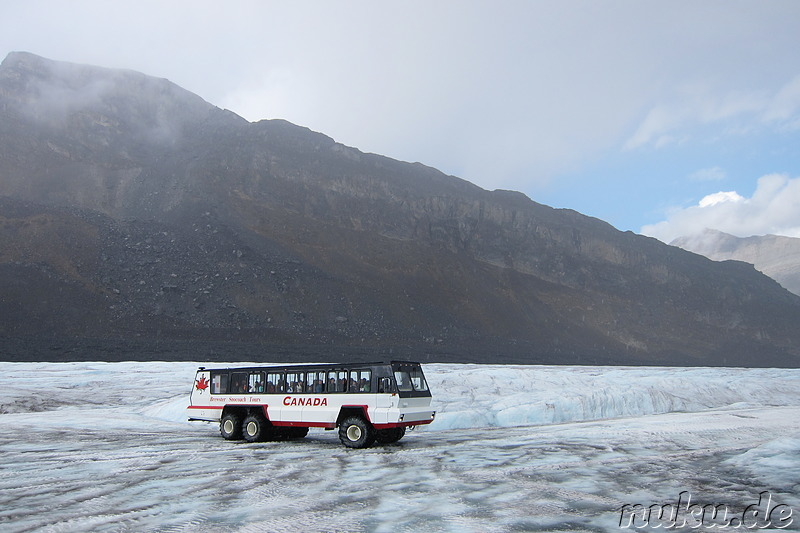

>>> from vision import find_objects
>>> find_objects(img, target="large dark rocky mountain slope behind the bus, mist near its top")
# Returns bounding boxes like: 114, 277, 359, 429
0, 53, 800, 366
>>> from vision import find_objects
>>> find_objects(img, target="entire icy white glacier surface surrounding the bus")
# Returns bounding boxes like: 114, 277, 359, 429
0, 363, 800, 532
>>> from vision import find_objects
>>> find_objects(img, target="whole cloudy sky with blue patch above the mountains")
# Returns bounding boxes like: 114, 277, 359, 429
0, 0, 800, 242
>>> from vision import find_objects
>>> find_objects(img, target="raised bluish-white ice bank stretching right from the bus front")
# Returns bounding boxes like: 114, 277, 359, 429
425, 365, 800, 429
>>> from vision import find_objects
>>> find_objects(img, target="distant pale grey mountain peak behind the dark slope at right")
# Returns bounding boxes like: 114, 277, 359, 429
670, 229, 800, 295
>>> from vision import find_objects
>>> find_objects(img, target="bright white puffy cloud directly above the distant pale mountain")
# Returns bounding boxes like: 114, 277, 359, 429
641, 174, 800, 243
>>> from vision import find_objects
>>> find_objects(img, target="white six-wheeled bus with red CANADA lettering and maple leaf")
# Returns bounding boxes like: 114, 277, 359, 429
187, 361, 436, 448
